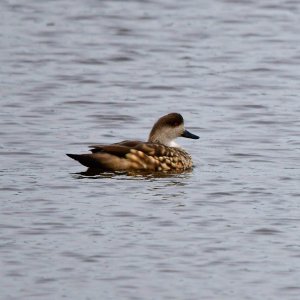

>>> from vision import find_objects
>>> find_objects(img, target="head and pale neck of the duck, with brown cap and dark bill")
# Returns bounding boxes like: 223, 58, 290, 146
148, 113, 199, 147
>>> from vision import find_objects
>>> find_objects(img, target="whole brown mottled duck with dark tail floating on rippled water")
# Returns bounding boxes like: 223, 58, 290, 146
66, 113, 199, 173
